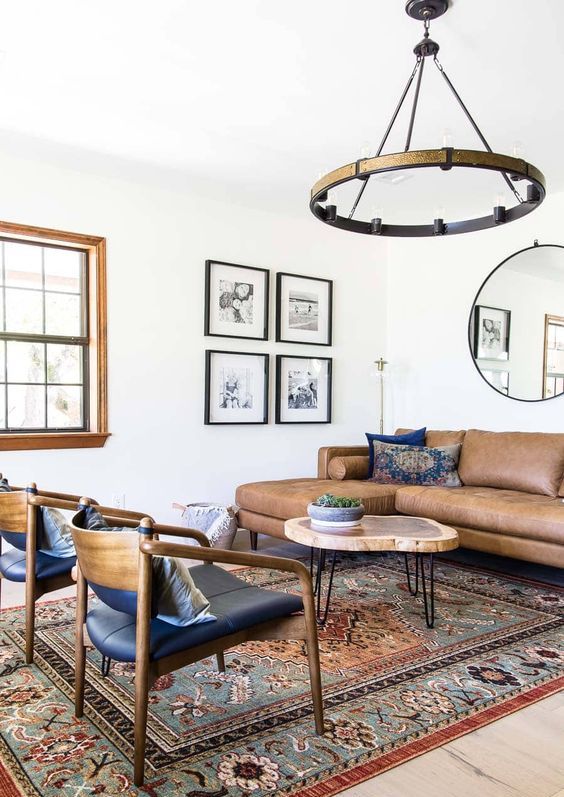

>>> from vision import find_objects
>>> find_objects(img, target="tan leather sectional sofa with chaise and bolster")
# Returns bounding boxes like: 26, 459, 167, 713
236, 429, 564, 567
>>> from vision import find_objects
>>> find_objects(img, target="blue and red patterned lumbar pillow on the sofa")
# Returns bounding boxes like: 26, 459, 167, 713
368, 440, 462, 487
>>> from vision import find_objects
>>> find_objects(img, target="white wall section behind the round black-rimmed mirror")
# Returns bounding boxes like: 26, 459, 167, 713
387, 194, 564, 432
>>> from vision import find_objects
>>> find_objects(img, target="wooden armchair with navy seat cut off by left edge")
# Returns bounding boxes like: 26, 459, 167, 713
0, 482, 96, 664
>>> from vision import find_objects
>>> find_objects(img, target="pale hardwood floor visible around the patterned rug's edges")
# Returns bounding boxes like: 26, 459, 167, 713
2, 533, 564, 797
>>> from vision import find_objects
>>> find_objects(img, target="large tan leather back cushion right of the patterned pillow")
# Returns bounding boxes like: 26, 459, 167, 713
458, 429, 564, 496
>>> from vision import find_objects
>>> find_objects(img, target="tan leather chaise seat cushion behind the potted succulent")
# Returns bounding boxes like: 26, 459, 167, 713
235, 479, 398, 520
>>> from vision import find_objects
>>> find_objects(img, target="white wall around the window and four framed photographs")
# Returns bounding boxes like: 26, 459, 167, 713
0, 151, 387, 521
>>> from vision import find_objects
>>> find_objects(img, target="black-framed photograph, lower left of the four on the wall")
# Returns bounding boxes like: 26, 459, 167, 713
204, 349, 269, 424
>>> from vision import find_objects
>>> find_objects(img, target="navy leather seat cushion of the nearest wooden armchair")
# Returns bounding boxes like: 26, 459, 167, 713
86, 565, 303, 661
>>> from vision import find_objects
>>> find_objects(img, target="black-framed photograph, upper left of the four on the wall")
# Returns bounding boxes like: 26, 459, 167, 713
204, 260, 270, 340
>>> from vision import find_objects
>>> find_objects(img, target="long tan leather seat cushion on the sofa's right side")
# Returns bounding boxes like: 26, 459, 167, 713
396, 485, 564, 545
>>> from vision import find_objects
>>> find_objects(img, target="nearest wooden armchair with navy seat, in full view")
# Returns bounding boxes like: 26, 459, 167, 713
72, 507, 323, 786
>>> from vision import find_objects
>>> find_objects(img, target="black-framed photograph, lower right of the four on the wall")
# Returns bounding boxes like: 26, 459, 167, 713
276, 354, 333, 423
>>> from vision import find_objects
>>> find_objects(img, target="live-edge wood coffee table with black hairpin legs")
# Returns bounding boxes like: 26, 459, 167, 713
284, 515, 459, 628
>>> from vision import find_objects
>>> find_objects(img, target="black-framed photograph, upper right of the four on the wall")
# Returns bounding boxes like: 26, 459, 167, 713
276, 272, 333, 346
